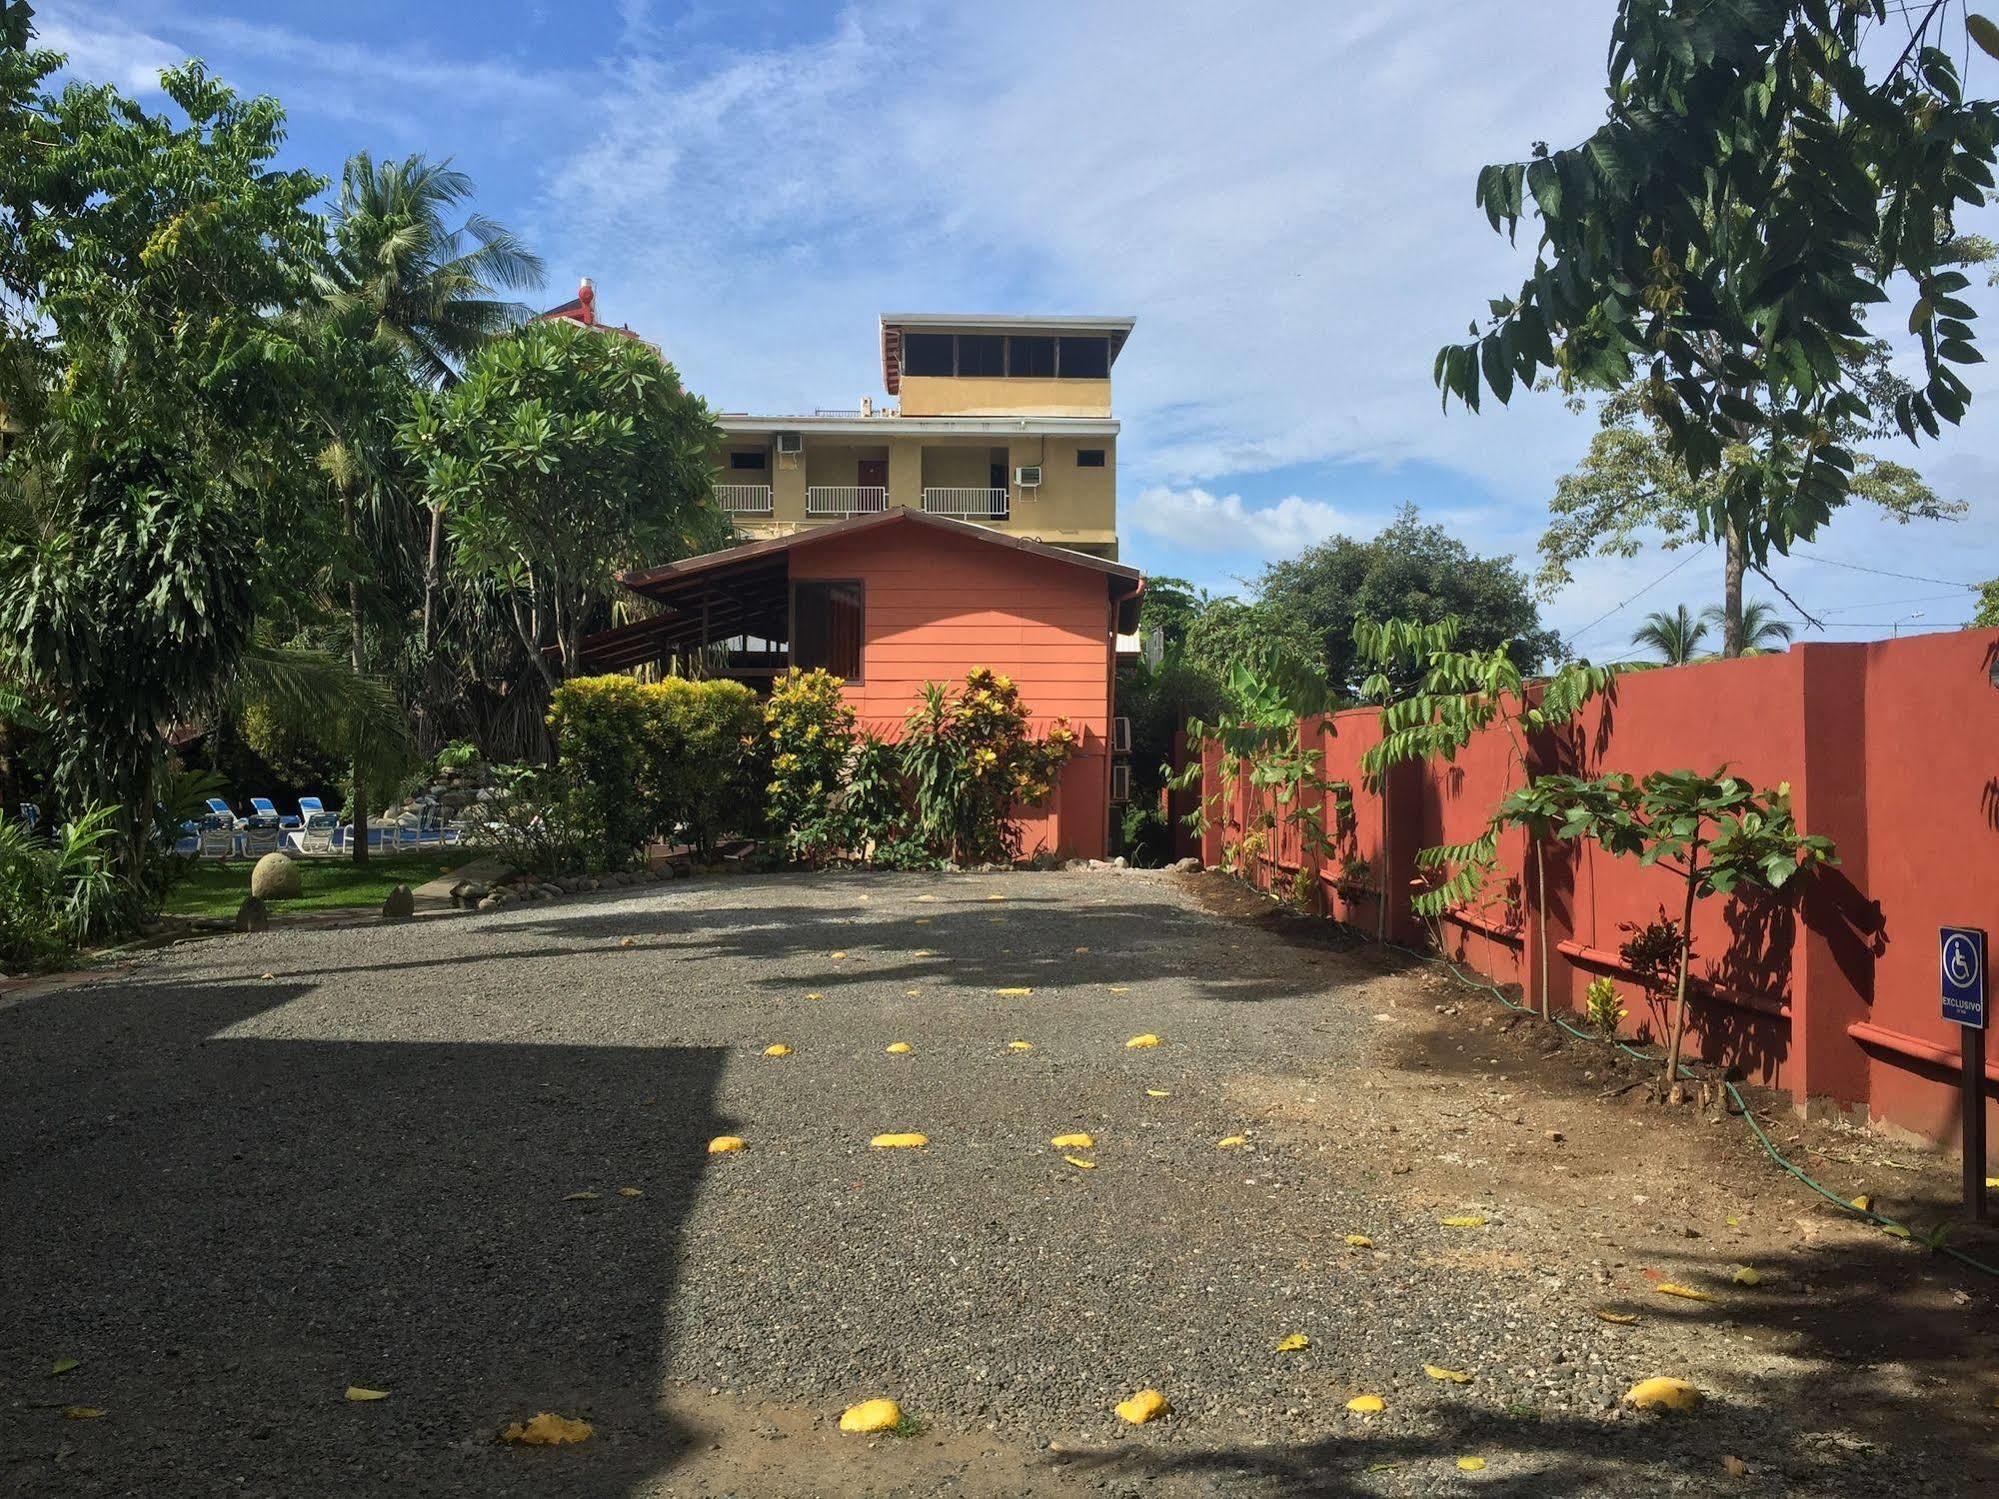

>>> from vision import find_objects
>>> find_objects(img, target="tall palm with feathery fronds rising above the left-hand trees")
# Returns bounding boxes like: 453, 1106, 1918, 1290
324, 152, 546, 658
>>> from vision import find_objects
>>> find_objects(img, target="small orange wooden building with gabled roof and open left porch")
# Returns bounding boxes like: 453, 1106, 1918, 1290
580, 508, 1143, 857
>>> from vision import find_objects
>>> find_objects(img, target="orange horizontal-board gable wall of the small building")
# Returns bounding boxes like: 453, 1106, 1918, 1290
792, 526, 1115, 859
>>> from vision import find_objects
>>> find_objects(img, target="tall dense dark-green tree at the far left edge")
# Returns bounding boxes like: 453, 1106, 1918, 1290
0, 38, 320, 871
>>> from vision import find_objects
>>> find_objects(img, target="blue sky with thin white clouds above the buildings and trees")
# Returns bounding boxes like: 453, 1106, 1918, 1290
54, 0, 1999, 656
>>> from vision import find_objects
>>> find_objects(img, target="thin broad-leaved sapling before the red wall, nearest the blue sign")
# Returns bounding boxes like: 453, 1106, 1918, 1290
1543, 767, 1839, 1103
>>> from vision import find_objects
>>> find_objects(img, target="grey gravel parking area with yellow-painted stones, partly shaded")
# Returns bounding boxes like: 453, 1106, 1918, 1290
0, 873, 1999, 1499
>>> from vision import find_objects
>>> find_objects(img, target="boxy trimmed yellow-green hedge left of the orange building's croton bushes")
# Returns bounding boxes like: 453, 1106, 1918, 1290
548, 676, 764, 869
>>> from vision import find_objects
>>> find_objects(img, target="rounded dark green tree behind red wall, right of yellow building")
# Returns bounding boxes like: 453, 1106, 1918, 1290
1255, 506, 1561, 698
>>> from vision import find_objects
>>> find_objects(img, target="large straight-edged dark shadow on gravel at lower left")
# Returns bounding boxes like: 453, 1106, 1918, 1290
0, 965, 728, 1499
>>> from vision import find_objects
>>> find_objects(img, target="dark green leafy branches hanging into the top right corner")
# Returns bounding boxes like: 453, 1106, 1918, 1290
1435, 0, 1999, 654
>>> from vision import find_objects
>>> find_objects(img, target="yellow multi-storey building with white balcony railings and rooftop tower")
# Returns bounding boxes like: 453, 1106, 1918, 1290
716, 312, 1133, 558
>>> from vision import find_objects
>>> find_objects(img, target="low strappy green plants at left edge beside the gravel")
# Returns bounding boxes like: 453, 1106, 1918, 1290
0, 807, 138, 973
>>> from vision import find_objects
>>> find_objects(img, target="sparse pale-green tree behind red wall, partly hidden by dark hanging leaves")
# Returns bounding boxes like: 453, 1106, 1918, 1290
1535, 351, 1985, 656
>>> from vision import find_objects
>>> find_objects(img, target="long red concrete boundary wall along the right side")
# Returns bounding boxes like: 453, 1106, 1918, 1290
1201, 630, 1999, 1139
